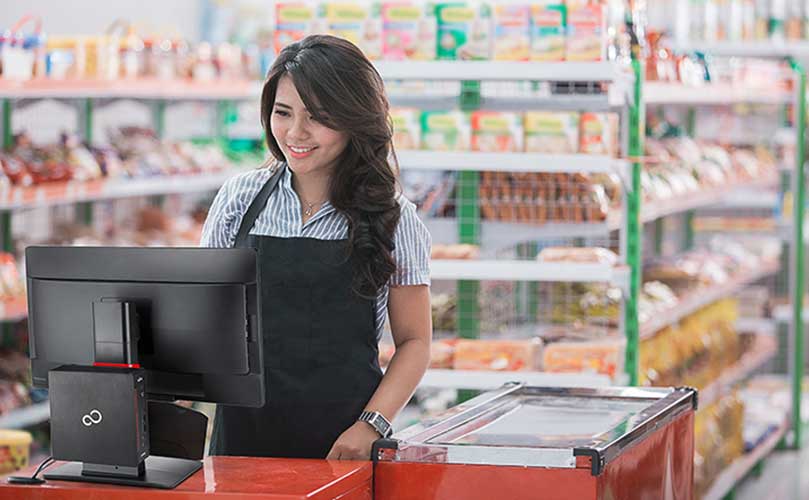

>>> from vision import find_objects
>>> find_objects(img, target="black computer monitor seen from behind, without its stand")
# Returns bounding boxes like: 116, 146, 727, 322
25, 246, 264, 407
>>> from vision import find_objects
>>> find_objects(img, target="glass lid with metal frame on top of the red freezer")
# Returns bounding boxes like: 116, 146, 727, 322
374, 383, 696, 475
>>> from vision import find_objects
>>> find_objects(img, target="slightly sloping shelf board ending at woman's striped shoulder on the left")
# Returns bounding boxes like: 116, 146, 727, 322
0, 171, 238, 210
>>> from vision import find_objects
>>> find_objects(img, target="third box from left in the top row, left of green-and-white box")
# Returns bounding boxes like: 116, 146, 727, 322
382, 2, 438, 61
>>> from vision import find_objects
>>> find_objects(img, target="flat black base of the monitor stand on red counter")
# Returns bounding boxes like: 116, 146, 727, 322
44, 456, 202, 489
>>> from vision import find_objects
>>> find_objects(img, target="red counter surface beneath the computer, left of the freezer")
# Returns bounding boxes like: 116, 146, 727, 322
0, 457, 373, 500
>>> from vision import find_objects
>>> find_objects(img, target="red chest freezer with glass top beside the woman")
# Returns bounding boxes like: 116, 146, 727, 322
373, 384, 697, 500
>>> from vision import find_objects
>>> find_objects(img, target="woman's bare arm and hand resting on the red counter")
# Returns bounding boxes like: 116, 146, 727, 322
326, 285, 433, 460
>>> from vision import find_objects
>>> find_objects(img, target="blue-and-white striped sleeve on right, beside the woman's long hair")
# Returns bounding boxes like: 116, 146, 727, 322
390, 197, 432, 286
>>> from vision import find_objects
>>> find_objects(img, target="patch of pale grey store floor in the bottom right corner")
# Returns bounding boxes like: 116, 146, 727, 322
735, 447, 809, 500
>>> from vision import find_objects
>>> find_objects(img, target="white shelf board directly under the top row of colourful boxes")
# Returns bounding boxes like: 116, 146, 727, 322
374, 61, 626, 82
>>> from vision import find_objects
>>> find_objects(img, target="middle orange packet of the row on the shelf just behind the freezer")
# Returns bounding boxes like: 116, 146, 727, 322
453, 338, 542, 371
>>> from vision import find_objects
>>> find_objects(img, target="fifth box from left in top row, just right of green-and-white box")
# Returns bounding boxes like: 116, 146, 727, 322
493, 4, 531, 61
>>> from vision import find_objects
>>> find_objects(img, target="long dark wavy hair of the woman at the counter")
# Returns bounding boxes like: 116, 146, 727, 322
261, 35, 400, 298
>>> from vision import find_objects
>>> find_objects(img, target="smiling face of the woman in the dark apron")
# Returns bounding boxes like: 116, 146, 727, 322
270, 75, 348, 180
